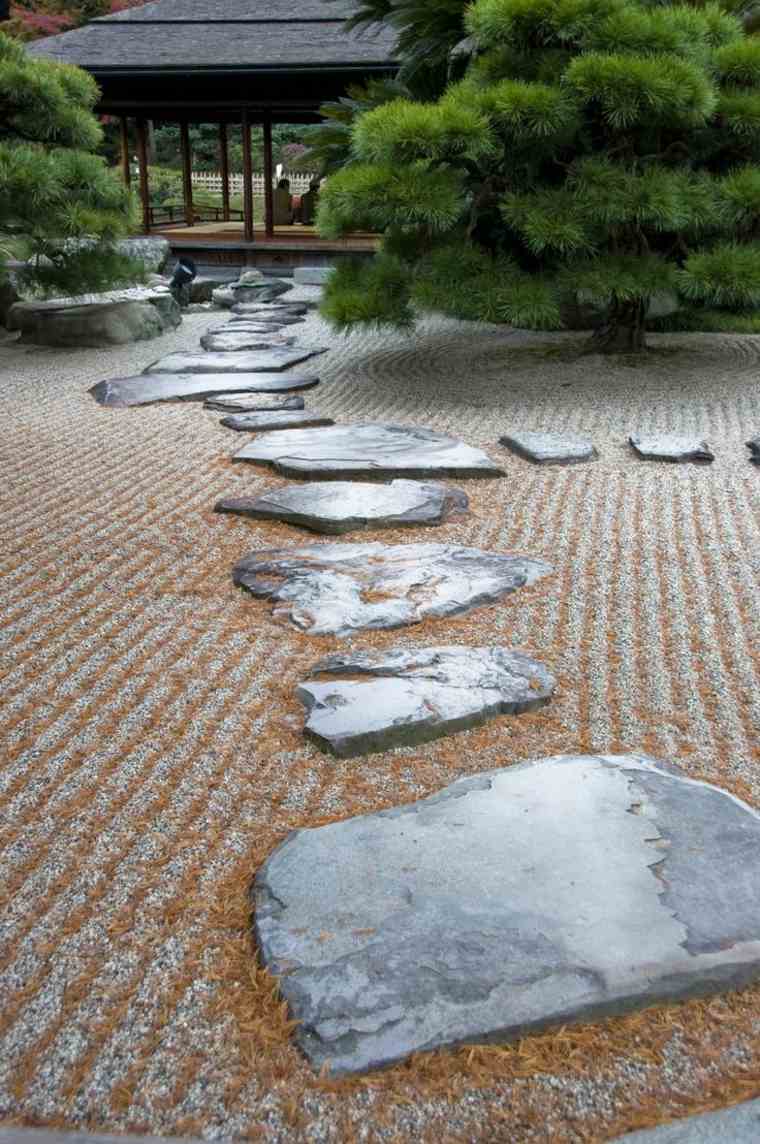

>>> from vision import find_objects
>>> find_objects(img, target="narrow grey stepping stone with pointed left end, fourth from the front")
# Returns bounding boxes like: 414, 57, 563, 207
215, 480, 469, 535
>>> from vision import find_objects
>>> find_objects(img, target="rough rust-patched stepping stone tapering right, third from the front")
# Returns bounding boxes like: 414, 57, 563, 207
232, 542, 552, 636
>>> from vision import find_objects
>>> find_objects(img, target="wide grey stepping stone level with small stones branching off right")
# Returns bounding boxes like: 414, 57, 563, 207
232, 424, 504, 477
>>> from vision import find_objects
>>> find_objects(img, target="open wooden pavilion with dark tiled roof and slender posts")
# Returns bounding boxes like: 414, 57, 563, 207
29, 0, 396, 262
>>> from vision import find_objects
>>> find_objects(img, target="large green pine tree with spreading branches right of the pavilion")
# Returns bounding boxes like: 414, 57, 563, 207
318, 0, 760, 350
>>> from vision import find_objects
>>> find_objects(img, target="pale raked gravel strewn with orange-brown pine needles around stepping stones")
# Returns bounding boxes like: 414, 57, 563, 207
0, 308, 760, 1142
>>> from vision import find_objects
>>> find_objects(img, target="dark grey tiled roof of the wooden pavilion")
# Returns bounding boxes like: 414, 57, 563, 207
29, 0, 395, 72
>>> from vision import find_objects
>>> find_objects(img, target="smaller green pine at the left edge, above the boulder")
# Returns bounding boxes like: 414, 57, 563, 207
0, 33, 138, 293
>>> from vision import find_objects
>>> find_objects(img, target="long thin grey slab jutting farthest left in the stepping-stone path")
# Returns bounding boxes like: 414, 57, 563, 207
89, 373, 319, 407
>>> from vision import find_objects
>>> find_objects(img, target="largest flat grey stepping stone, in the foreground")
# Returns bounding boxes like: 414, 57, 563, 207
254, 755, 760, 1073
